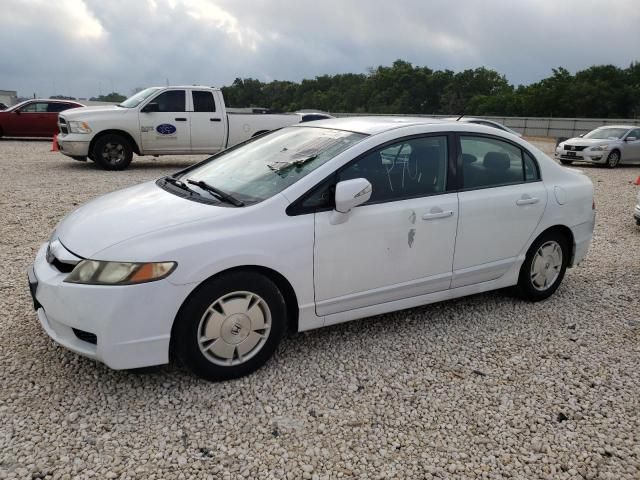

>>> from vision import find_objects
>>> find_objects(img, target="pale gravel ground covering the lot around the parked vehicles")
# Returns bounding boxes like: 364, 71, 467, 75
0, 141, 640, 479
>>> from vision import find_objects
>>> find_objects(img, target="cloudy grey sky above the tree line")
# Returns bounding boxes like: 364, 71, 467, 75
0, 0, 640, 97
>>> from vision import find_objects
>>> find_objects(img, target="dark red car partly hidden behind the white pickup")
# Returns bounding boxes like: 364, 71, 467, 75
0, 99, 84, 138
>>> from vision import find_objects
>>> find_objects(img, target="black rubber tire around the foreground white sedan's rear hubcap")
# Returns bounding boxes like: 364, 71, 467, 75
516, 231, 571, 302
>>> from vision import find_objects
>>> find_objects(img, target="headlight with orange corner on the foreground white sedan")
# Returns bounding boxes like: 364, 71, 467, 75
64, 260, 177, 285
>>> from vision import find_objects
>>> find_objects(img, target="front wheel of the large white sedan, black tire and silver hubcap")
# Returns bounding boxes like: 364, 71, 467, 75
172, 271, 287, 381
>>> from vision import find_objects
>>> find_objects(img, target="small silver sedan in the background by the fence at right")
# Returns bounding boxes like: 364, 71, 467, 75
555, 125, 640, 168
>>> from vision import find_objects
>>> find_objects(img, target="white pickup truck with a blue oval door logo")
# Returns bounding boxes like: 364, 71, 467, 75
57, 86, 303, 170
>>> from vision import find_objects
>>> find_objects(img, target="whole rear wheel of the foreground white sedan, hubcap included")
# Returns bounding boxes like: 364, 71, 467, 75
517, 231, 569, 302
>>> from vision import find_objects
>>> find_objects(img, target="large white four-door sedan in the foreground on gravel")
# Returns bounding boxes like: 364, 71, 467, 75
29, 117, 595, 380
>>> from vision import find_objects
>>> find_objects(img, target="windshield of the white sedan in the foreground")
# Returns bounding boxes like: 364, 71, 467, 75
180, 127, 366, 203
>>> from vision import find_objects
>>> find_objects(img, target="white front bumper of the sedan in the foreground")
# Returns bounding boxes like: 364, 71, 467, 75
28, 244, 192, 370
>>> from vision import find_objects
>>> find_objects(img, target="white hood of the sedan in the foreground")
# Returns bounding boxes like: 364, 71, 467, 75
54, 182, 242, 260
